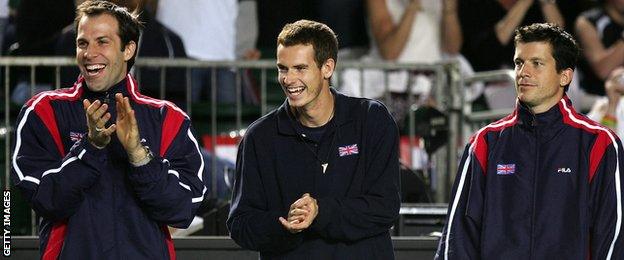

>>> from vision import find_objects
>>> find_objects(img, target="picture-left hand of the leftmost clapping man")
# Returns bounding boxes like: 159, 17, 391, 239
82, 99, 116, 149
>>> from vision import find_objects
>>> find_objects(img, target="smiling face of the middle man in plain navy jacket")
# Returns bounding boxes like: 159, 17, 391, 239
277, 44, 334, 109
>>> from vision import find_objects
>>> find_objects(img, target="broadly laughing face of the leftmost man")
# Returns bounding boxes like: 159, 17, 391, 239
76, 14, 136, 91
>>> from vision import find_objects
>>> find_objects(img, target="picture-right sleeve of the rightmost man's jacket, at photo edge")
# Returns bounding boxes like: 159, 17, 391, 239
590, 135, 624, 259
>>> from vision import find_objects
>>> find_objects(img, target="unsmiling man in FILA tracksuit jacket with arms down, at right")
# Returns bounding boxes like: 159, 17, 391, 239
436, 24, 624, 259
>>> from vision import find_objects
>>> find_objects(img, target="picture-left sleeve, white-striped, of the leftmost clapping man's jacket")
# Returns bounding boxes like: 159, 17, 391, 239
11, 106, 107, 220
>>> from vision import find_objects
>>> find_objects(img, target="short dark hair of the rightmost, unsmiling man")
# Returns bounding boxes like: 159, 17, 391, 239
514, 23, 580, 72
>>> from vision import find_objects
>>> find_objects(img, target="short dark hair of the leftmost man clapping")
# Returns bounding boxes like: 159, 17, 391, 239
74, 0, 142, 71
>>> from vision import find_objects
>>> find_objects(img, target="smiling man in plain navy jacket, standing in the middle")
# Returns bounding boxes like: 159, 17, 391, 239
227, 20, 400, 259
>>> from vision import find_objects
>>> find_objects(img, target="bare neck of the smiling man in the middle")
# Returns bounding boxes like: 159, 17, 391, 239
292, 90, 334, 127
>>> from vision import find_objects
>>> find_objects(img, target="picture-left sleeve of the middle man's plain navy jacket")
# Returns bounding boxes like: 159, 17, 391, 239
227, 132, 303, 252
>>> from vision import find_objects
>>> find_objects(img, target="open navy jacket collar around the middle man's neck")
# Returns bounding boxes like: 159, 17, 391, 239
277, 88, 353, 135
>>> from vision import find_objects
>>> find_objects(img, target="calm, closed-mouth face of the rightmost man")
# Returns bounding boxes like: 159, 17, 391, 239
514, 42, 572, 113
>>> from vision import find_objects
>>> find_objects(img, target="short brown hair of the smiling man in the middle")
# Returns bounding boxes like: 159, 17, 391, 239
277, 20, 338, 68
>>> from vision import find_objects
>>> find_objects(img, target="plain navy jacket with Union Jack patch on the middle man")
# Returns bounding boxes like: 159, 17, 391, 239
227, 89, 400, 260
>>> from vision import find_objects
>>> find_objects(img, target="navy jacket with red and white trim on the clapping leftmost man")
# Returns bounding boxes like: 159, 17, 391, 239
11, 75, 206, 259
